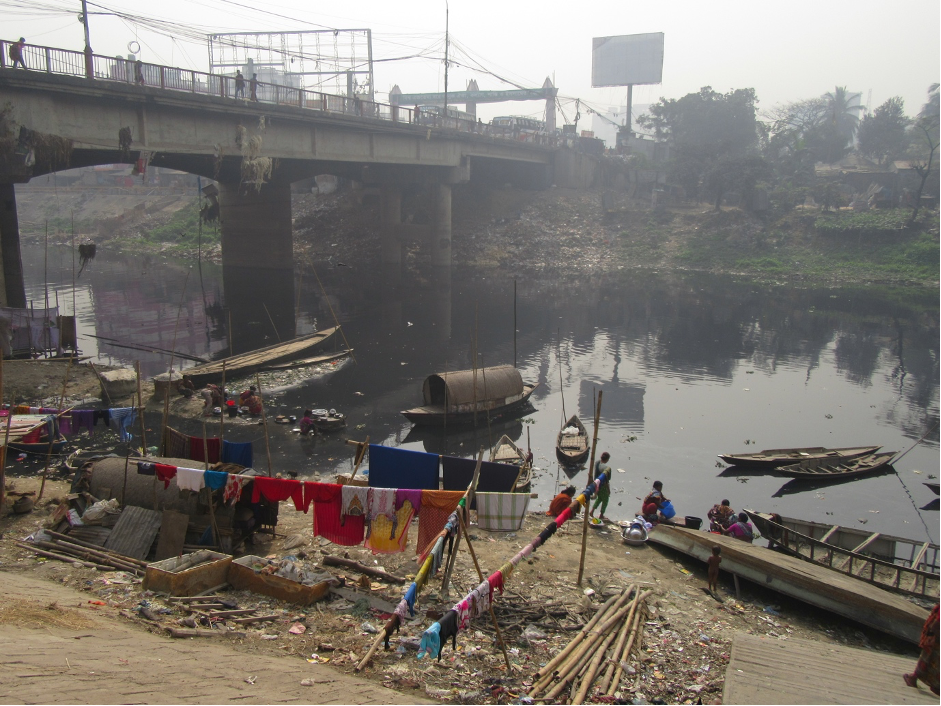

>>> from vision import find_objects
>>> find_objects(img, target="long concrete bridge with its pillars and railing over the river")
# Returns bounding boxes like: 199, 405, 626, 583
0, 42, 592, 306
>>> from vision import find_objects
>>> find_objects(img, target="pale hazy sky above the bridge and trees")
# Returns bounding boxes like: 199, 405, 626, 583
0, 0, 941, 123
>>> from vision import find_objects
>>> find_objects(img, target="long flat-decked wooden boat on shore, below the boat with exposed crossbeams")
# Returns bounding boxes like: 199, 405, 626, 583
649, 525, 928, 644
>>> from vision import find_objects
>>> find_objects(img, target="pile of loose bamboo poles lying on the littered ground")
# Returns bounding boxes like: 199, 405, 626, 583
528, 585, 650, 704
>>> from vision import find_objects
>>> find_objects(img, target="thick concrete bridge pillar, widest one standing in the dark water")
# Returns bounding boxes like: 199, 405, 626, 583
219, 182, 294, 271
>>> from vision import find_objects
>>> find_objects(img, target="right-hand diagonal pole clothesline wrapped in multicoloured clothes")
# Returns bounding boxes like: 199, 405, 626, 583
416, 473, 608, 660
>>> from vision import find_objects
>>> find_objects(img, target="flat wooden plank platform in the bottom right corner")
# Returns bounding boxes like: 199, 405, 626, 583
722, 632, 938, 706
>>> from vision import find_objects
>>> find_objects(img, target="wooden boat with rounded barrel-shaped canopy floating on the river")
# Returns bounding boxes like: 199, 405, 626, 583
402, 365, 539, 427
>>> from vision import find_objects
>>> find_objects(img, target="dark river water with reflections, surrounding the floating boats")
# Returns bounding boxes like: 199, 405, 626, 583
23, 245, 941, 542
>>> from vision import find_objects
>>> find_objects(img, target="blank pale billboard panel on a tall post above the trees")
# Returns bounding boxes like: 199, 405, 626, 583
591, 32, 663, 88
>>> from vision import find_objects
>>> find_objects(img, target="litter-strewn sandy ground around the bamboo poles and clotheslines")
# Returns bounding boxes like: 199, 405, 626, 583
0, 479, 916, 703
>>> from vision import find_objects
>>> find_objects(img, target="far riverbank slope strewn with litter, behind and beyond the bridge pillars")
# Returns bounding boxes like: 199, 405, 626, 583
20, 184, 941, 288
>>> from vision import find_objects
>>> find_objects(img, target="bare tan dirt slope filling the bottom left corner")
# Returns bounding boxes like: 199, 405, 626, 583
0, 571, 432, 704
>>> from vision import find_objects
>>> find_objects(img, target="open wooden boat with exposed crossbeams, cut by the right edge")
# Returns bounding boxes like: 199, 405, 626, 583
745, 510, 941, 599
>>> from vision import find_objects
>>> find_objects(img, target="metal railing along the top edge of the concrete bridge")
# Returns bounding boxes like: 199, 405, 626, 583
0, 40, 506, 140
